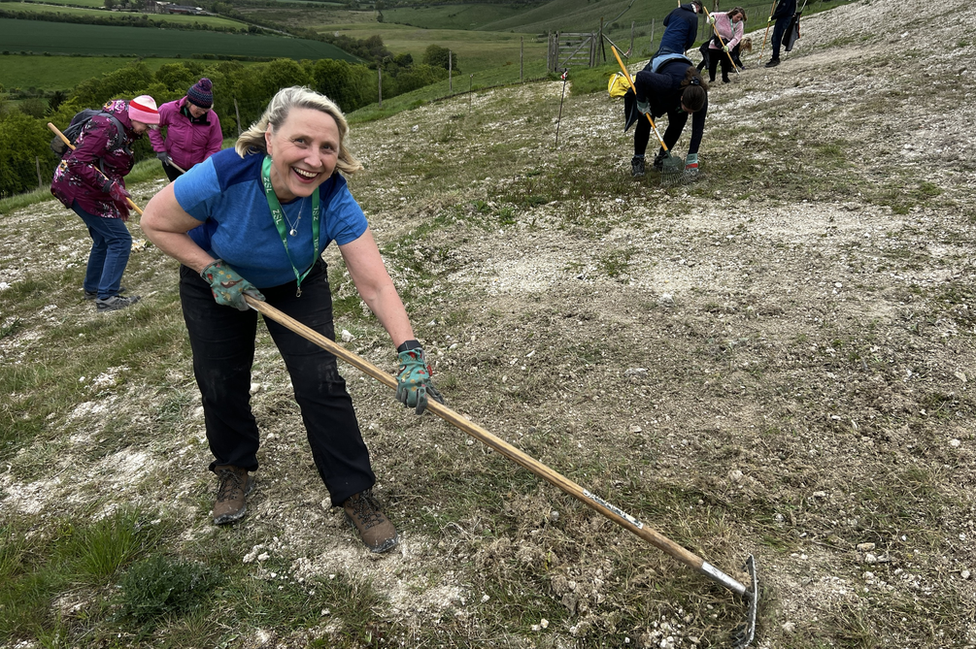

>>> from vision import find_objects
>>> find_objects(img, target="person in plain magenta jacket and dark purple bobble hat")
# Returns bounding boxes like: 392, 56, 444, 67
149, 77, 224, 181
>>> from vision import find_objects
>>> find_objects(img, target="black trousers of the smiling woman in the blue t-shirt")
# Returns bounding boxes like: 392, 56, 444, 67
180, 260, 376, 506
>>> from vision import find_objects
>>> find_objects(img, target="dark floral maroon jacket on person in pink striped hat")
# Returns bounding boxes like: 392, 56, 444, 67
51, 99, 139, 220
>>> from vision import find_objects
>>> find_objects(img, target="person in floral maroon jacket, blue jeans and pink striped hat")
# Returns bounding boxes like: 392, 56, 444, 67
51, 95, 159, 311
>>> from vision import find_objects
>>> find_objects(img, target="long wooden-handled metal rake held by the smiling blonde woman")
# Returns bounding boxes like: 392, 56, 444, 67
244, 295, 759, 649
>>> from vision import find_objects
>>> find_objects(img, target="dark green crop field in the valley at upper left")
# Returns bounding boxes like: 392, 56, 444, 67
0, 18, 356, 61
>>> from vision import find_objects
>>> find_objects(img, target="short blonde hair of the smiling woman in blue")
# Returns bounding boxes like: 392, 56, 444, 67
234, 86, 363, 175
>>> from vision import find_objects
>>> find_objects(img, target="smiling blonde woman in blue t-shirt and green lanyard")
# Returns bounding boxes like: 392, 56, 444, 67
141, 87, 441, 552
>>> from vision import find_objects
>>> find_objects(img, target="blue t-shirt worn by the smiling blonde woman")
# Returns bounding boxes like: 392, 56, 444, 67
173, 149, 367, 288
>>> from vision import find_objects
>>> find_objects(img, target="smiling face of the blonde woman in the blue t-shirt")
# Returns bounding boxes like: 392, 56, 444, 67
264, 108, 339, 201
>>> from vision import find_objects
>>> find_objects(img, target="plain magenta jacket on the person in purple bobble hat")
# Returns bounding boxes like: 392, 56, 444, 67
149, 97, 224, 171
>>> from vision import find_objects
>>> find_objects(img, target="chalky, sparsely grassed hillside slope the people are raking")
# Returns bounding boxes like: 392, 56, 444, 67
0, 0, 976, 649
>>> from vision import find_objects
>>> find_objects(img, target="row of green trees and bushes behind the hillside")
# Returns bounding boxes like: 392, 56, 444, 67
0, 45, 457, 198
